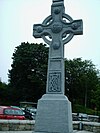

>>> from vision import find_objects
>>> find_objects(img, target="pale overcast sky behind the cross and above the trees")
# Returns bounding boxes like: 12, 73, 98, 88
0, 0, 100, 83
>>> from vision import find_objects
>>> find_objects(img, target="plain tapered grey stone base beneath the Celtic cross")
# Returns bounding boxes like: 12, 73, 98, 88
35, 94, 73, 133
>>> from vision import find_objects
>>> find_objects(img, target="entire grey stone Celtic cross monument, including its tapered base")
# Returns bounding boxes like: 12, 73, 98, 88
33, 0, 83, 133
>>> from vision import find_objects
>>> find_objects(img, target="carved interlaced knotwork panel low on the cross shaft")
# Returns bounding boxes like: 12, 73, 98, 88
48, 72, 61, 93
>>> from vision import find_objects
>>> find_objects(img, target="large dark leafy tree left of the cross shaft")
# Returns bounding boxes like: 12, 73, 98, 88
8, 42, 48, 104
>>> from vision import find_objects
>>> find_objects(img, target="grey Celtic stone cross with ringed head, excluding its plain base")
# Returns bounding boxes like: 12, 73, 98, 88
33, 0, 83, 94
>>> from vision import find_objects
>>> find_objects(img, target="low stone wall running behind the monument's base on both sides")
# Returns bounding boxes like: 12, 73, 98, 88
0, 120, 100, 133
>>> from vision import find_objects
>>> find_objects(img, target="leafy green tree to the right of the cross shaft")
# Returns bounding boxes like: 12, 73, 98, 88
65, 58, 98, 107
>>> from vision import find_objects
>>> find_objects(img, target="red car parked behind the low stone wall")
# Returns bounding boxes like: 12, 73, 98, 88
0, 106, 25, 120
